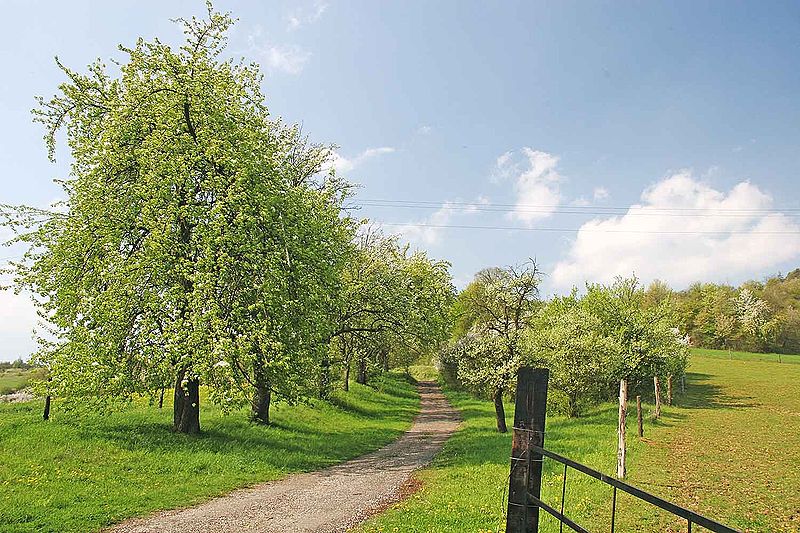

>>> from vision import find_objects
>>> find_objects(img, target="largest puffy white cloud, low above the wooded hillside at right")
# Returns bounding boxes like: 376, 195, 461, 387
550, 171, 800, 289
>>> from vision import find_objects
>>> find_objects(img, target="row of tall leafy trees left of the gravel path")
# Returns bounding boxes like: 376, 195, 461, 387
3, 5, 453, 433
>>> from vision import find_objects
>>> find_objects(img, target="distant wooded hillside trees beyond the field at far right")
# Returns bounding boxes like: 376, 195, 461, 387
645, 269, 800, 353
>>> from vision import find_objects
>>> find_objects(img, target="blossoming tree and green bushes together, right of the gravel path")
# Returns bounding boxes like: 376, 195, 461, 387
440, 263, 688, 432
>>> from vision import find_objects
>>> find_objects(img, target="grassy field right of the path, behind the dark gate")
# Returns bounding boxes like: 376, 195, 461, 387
361, 352, 800, 533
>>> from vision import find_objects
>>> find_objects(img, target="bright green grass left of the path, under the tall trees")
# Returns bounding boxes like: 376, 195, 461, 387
0, 374, 419, 533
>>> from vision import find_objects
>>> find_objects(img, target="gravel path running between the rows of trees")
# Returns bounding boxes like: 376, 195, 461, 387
110, 382, 459, 533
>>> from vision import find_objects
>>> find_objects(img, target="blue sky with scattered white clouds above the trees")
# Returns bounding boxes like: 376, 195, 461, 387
0, 0, 800, 359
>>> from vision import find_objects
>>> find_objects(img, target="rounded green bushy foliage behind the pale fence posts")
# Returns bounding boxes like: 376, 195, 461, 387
525, 278, 688, 416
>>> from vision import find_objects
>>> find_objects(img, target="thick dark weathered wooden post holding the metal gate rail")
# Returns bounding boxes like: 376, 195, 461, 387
506, 367, 550, 533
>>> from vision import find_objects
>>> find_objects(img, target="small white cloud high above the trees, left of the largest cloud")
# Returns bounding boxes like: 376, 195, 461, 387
492, 147, 563, 226
